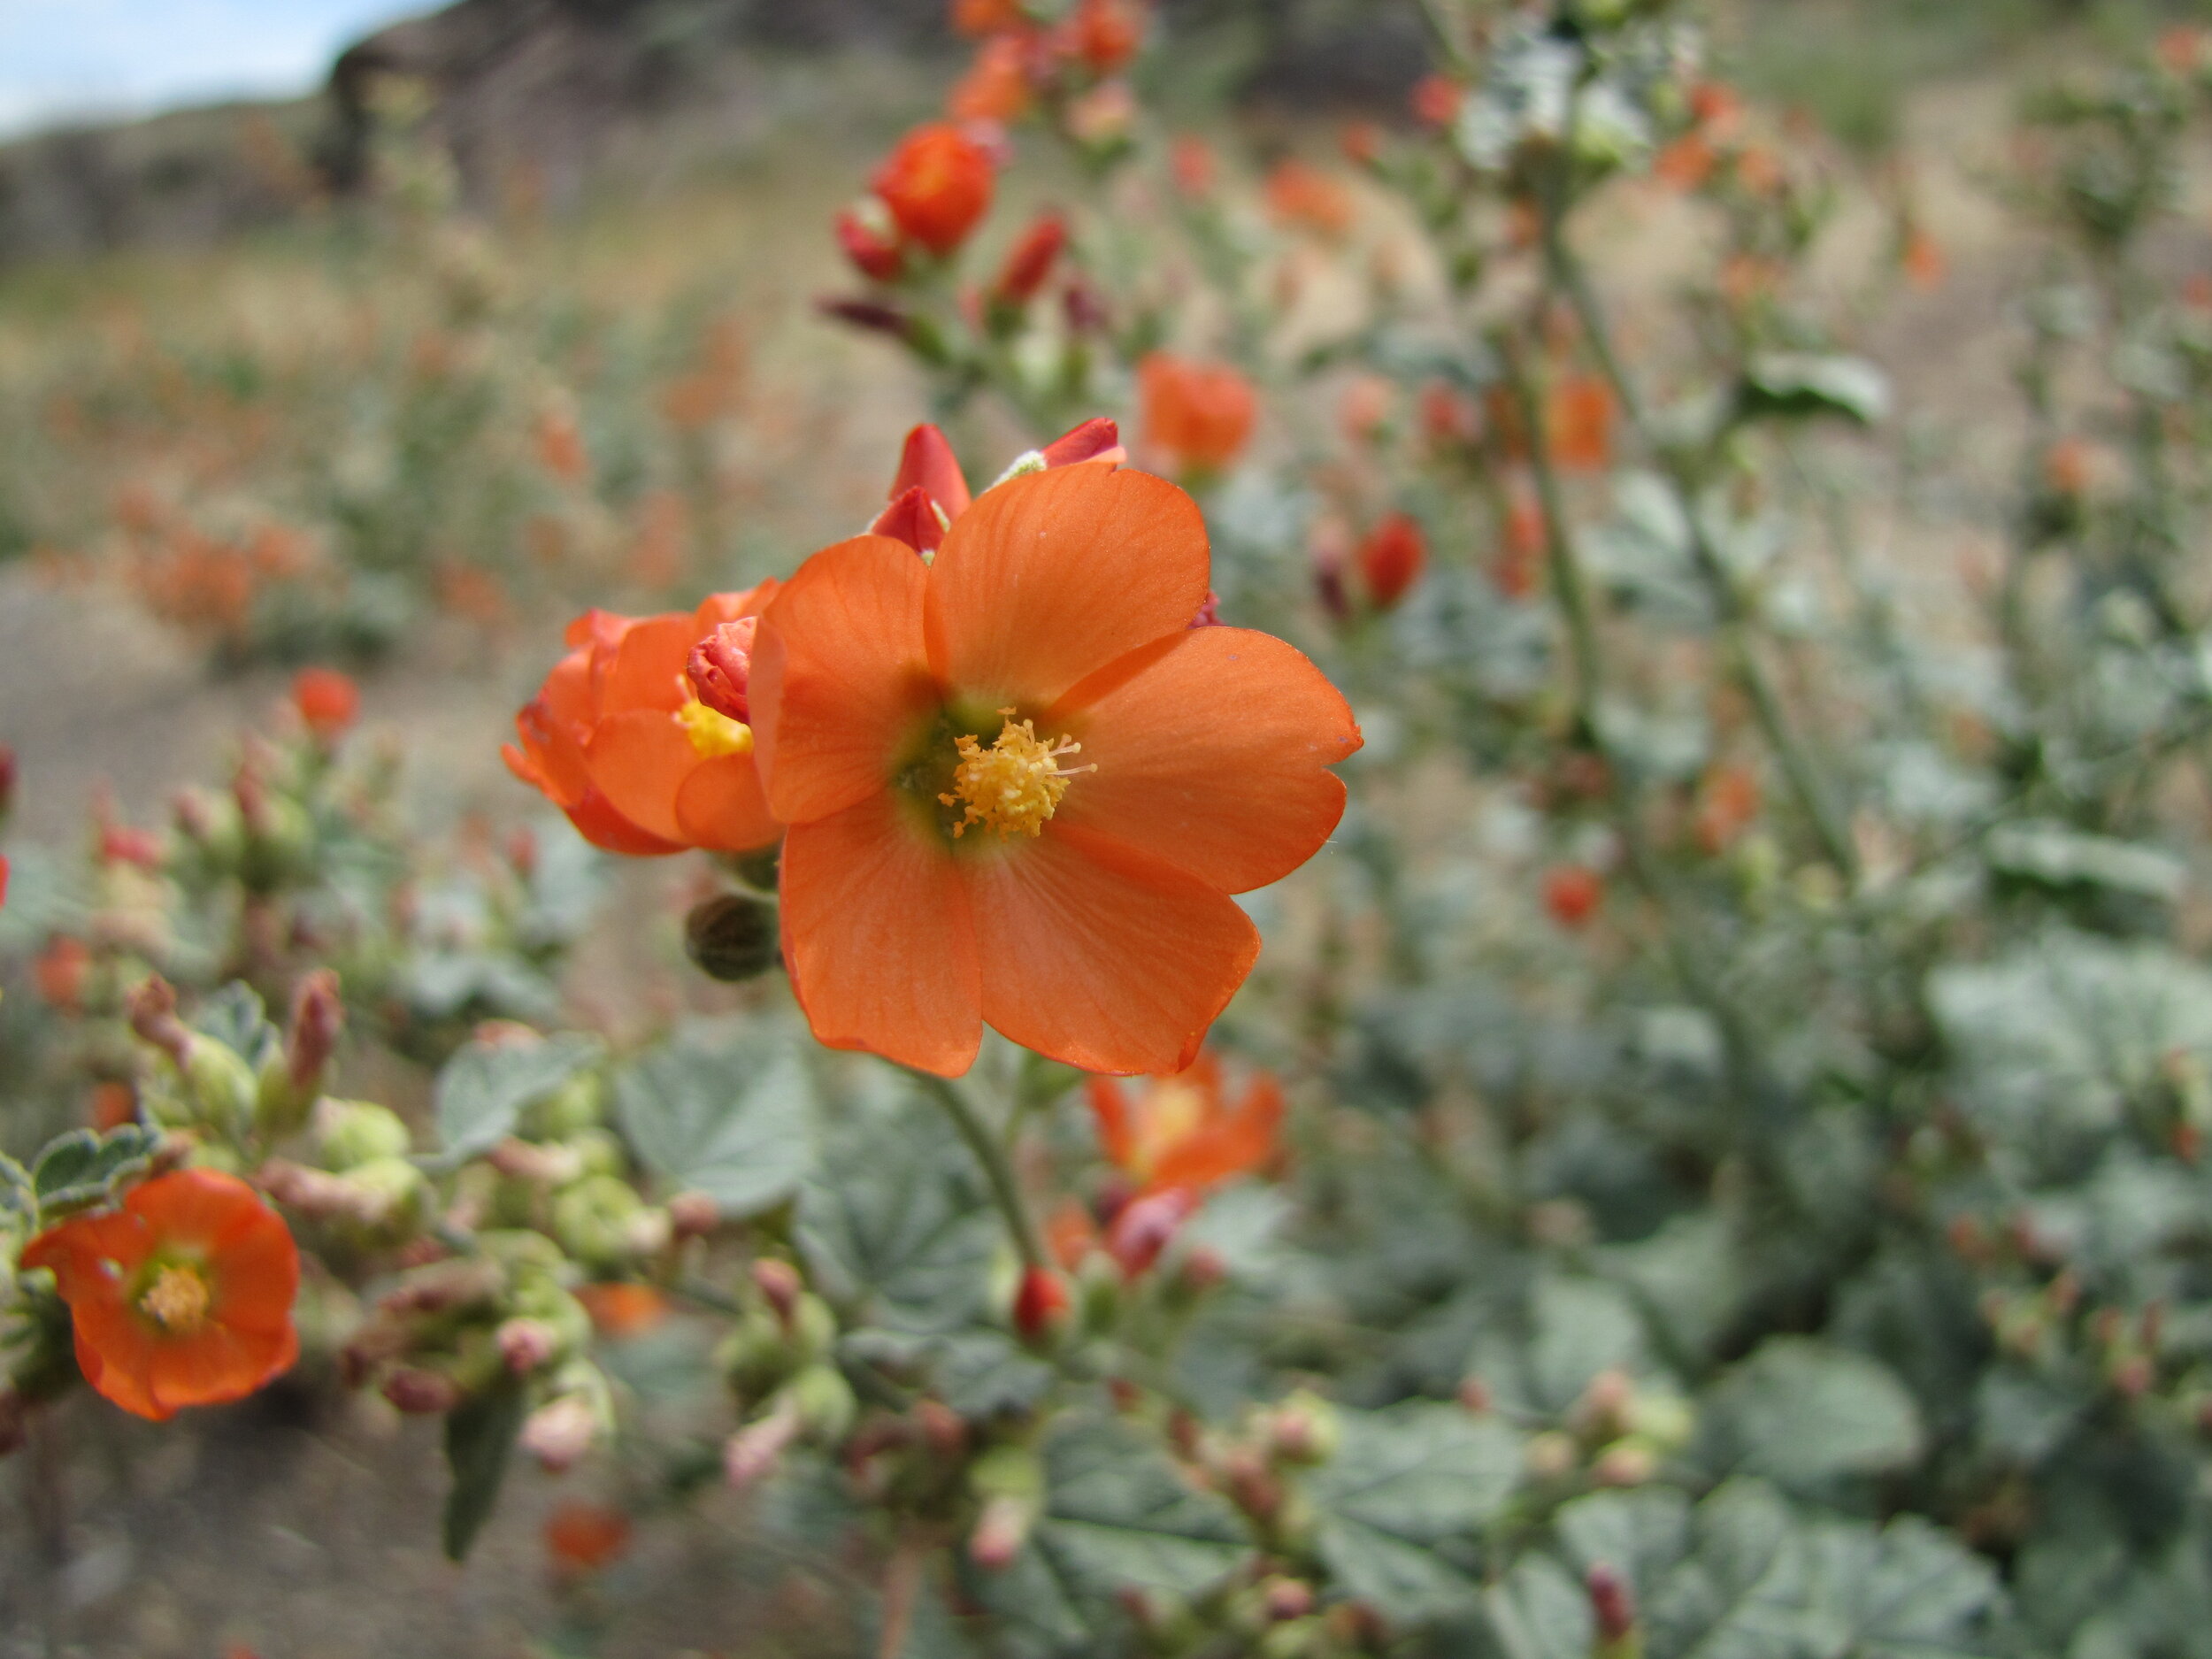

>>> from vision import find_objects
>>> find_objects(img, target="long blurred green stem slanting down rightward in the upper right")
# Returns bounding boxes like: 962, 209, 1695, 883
1544, 214, 1861, 887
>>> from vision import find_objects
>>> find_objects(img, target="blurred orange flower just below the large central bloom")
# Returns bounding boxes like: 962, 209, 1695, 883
1088, 1056, 1283, 1194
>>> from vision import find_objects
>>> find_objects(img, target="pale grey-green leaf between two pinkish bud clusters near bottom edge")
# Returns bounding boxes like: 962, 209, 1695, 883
1310, 1402, 1522, 1624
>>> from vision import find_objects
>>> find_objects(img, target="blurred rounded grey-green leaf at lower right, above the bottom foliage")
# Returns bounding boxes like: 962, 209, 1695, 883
1706, 1336, 1924, 1486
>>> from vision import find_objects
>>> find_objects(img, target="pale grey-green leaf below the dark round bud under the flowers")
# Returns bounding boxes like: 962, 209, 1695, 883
615, 1038, 814, 1217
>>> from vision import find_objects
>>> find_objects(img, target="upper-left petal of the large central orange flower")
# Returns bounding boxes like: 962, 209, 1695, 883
750, 535, 936, 823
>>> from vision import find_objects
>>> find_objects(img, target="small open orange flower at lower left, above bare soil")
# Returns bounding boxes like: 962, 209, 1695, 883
22, 1171, 299, 1420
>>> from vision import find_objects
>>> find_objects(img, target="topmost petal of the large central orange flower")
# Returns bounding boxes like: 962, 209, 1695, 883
929, 467, 1210, 706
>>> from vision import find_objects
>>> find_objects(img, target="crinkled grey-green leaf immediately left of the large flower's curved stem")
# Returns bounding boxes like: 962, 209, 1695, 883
799, 1095, 1000, 1332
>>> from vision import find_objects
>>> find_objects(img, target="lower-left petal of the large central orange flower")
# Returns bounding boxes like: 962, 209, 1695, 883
783, 792, 982, 1078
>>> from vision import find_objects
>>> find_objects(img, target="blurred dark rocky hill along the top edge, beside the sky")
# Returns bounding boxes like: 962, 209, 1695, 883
0, 0, 1423, 261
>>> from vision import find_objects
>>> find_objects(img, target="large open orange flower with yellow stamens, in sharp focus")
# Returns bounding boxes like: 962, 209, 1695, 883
752, 467, 1361, 1075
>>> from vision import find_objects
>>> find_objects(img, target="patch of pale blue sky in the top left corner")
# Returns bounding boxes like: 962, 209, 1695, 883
0, 0, 420, 133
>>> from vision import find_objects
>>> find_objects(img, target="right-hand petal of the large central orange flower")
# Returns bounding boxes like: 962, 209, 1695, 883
1044, 628, 1361, 894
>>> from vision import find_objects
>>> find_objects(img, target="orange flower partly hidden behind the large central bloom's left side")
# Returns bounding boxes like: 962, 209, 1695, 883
503, 582, 777, 858
